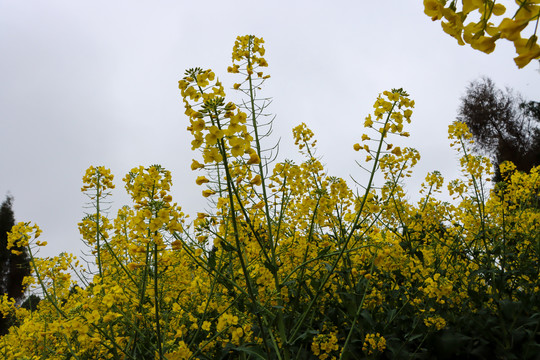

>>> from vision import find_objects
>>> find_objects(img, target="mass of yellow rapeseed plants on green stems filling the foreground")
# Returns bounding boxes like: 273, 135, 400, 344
0, 36, 540, 360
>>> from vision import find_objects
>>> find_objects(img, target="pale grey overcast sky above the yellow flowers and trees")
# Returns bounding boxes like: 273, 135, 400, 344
0, 0, 540, 255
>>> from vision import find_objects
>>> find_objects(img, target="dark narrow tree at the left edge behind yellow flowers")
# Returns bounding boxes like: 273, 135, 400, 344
0, 196, 30, 334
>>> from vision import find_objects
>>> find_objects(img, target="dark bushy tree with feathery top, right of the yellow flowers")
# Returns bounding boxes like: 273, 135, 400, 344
457, 78, 540, 181
